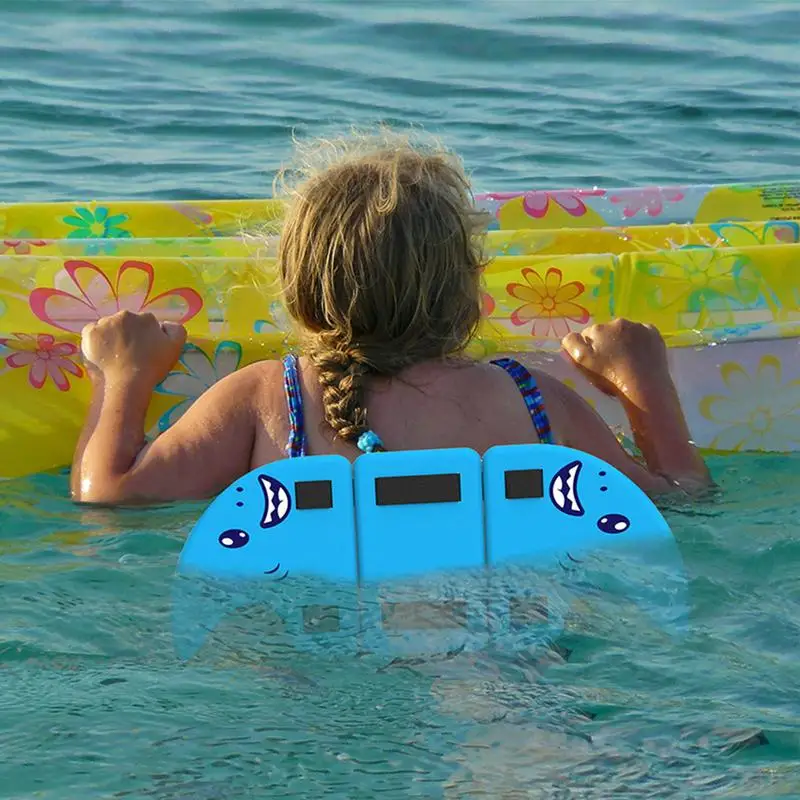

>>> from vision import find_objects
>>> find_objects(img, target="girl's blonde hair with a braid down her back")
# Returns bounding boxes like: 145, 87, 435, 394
278, 129, 484, 441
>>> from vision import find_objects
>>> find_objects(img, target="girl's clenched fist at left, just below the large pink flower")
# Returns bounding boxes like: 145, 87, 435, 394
81, 311, 186, 388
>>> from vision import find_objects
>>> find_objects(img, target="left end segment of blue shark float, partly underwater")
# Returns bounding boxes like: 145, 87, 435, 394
173, 456, 359, 659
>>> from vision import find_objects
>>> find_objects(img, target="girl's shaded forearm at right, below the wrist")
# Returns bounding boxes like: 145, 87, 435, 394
620, 381, 711, 485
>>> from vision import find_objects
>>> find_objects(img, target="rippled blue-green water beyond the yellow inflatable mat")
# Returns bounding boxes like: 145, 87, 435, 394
0, 0, 800, 201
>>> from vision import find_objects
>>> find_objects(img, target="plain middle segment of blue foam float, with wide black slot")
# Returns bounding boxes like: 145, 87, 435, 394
354, 448, 488, 656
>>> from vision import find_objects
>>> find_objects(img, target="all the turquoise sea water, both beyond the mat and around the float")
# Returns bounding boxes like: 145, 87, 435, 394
0, 0, 800, 800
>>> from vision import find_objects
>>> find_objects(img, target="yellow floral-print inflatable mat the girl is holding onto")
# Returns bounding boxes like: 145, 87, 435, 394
0, 187, 800, 477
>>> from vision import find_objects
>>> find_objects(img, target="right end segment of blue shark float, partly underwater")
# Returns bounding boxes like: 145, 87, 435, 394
483, 444, 689, 646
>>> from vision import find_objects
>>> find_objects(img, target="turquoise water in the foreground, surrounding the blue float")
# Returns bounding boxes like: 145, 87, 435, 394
0, 456, 800, 799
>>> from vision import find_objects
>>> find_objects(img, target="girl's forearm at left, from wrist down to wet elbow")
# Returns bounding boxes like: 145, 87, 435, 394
71, 376, 152, 502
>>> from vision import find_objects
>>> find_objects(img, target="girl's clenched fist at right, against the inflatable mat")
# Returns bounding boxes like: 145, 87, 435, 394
561, 319, 672, 398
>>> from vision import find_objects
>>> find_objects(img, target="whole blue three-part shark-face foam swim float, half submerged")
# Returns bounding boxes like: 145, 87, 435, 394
174, 444, 687, 658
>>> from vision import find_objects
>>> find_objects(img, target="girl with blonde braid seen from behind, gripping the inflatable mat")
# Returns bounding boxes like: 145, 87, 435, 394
67, 134, 709, 504
